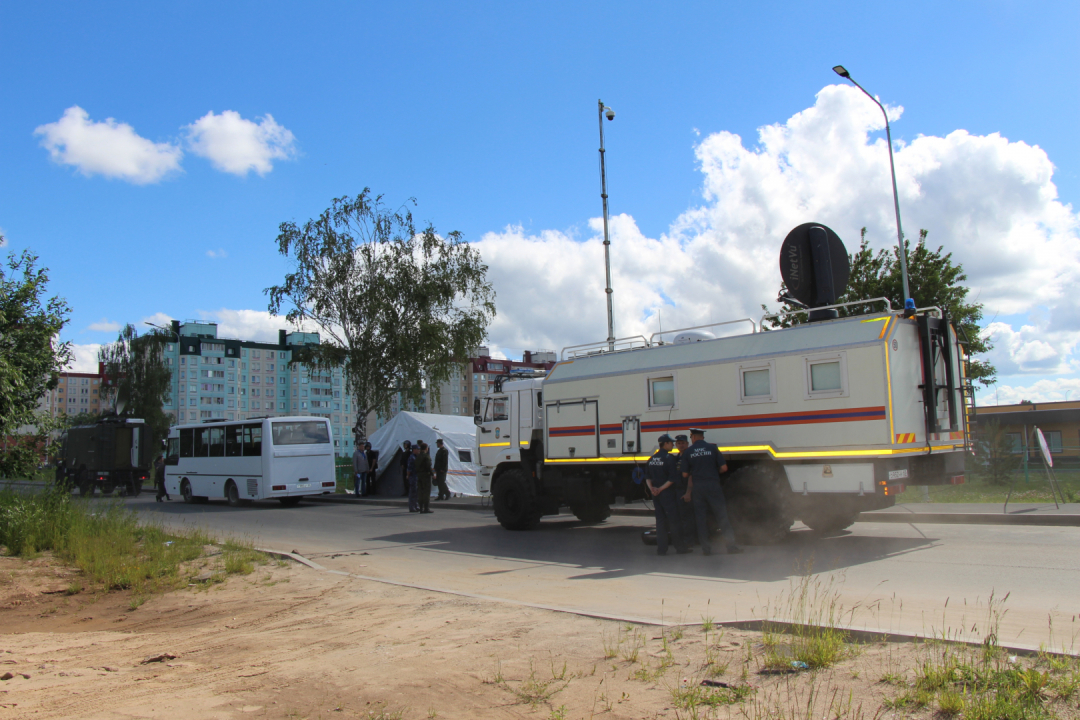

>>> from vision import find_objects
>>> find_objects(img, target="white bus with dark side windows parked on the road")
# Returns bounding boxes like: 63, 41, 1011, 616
165, 417, 337, 506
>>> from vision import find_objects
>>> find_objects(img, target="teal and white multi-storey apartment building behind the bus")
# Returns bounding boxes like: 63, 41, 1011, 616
158, 321, 356, 456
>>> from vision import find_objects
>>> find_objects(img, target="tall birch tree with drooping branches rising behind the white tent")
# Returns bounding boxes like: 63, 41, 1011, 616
266, 188, 495, 436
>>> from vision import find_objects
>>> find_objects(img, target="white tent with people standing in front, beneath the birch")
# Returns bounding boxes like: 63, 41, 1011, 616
368, 412, 480, 495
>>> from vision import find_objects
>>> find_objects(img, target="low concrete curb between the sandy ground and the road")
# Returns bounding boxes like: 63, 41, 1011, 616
255, 547, 1075, 657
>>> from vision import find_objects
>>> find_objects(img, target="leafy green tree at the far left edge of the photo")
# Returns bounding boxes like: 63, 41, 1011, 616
0, 248, 71, 477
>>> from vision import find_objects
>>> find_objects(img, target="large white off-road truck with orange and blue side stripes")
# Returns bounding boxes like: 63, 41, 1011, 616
474, 225, 970, 543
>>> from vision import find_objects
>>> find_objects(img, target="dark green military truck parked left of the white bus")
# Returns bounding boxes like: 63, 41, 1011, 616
60, 416, 153, 497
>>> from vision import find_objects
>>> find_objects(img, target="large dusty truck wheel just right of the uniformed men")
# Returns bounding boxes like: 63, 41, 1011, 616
724, 465, 795, 545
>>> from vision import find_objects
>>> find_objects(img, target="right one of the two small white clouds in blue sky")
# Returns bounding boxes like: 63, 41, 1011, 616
185, 110, 296, 176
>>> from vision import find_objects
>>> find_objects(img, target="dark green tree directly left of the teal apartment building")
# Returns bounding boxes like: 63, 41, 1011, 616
97, 324, 172, 447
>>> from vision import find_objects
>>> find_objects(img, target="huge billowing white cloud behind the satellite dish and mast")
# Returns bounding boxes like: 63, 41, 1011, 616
476, 85, 1080, 372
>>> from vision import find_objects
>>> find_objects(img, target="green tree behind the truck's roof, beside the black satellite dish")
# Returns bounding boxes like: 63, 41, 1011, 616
762, 228, 997, 385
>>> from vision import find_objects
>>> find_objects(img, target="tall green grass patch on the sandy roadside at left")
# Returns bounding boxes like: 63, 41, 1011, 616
0, 489, 266, 595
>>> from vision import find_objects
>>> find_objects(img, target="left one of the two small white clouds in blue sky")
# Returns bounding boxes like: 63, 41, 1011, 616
33, 105, 184, 185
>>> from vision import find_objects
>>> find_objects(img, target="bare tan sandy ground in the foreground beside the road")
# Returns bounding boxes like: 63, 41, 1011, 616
0, 557, 1076, 720
